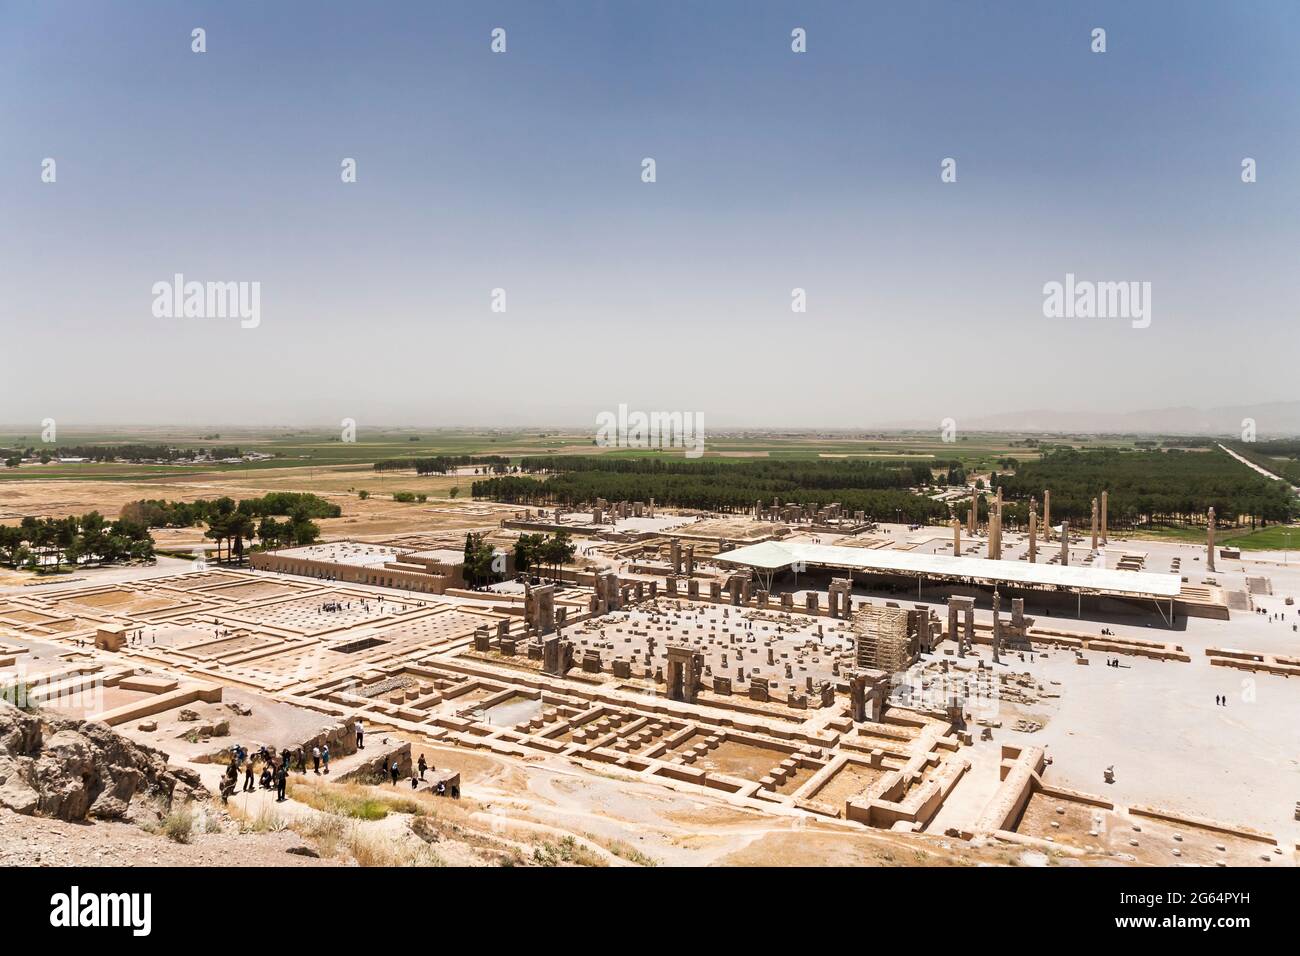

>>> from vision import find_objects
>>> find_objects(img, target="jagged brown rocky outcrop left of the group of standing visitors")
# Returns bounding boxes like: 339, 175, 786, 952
0, 701, 207, 821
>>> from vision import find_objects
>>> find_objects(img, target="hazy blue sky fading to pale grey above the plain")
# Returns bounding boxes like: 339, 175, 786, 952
0, 0, 1300, 427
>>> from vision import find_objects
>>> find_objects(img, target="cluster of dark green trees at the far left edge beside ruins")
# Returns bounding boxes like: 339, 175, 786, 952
0, 511, 153, 571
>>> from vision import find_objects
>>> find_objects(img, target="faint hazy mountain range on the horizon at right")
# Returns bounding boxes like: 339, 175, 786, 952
958, 401, 1300, 438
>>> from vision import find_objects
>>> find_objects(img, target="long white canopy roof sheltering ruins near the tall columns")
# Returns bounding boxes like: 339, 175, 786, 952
716, 541, 1183, 597
